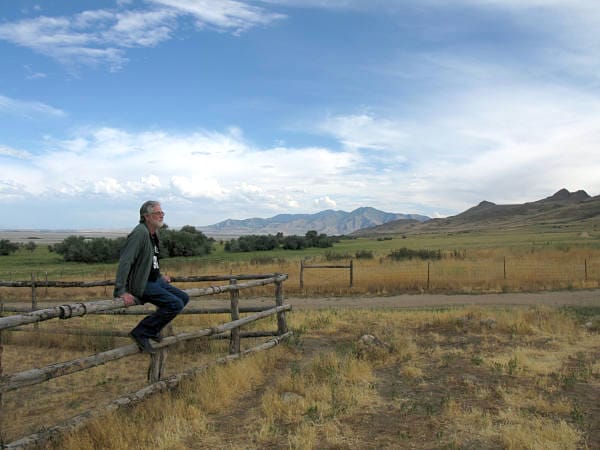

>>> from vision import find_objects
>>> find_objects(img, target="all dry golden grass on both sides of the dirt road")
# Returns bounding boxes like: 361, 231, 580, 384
0, 239, 600, 450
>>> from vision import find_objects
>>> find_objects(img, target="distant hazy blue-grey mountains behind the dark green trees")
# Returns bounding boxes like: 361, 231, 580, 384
196, 207, 430, 237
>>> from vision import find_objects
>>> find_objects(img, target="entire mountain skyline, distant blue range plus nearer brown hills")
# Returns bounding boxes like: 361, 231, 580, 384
197, 189, 600, 237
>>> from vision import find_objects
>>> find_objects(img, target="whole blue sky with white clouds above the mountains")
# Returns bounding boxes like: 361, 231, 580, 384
0, 0, 600, 229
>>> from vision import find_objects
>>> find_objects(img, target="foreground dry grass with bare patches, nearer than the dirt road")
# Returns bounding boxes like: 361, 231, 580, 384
3, 305, 600, 450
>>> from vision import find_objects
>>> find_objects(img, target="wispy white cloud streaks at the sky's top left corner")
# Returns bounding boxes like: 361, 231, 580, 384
0, 0, 284, 71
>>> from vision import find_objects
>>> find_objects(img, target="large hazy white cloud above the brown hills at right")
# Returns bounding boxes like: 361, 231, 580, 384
319, 74, 600, 214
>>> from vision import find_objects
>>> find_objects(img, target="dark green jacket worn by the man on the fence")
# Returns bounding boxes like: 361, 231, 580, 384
113, 223, 154, 300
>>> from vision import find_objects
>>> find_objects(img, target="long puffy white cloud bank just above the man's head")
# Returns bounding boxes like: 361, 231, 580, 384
0, 128, 360, 213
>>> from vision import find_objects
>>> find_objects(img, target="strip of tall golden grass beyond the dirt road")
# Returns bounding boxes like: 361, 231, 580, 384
0, 244, 600, 303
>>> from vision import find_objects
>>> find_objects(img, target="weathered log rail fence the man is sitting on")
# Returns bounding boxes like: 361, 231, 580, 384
0, 273, 291, 449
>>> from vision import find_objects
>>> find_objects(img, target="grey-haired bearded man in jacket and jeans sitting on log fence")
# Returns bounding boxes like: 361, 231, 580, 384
114, 200, 189, 353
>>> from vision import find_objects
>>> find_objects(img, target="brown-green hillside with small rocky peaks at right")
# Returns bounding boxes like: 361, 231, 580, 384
353, 189, 600, 236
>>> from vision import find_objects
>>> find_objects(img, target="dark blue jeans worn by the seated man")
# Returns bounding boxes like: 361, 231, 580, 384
131, 278, 190, 338
